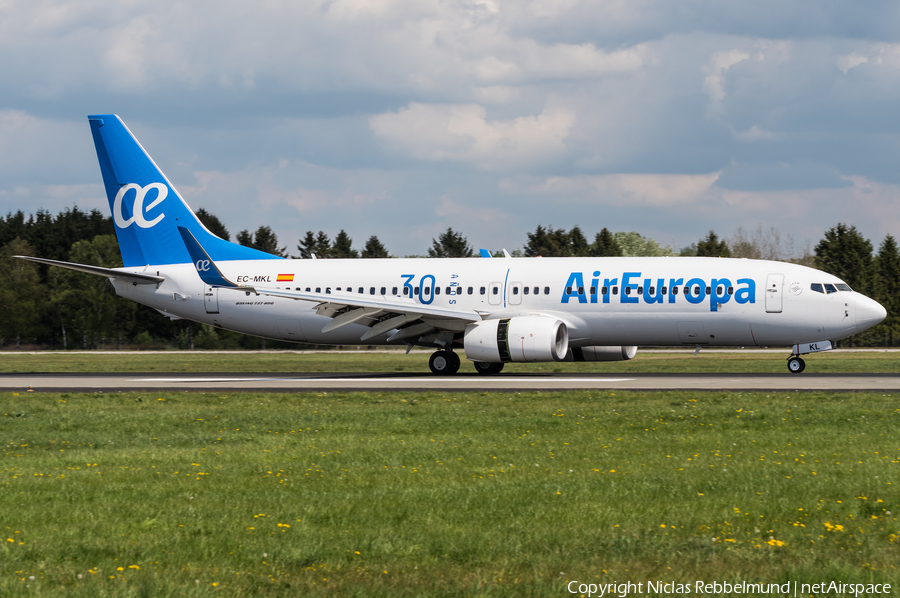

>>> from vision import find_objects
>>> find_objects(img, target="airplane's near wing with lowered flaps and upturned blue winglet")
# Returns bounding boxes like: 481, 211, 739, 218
178, 227, 482, 346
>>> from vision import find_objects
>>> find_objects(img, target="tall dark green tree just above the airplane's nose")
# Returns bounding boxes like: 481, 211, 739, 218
815, 223, 874, 295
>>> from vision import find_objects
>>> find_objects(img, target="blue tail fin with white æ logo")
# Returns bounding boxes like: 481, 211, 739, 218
88, 114, 281, 267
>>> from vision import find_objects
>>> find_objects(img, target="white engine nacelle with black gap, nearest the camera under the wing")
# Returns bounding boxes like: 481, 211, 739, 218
463, 316, 569, 363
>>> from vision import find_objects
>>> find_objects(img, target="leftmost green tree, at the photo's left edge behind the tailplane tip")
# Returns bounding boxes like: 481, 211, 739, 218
0, 239, 44, 349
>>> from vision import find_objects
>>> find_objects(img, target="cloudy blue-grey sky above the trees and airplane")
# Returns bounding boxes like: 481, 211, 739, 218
0, 0, 900, 255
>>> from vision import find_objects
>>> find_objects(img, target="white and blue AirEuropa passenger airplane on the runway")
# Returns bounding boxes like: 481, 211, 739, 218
17, 114, 887, 375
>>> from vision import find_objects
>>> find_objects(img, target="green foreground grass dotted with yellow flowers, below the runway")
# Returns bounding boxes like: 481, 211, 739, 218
0, 392, 900, 597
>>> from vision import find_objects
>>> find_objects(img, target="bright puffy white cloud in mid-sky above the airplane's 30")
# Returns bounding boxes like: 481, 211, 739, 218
369, 102, 576, 170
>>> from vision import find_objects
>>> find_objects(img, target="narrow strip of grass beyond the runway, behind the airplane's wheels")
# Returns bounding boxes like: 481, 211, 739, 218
0, 349, 900, 374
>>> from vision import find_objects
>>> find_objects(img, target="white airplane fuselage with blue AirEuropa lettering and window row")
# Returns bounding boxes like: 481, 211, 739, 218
113, 257, 884, 347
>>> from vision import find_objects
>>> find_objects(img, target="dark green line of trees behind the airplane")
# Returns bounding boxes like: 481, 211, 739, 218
0, 207, 900, 349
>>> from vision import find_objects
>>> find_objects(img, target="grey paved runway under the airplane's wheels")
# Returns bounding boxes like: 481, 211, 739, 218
0, 373, 900, 393
